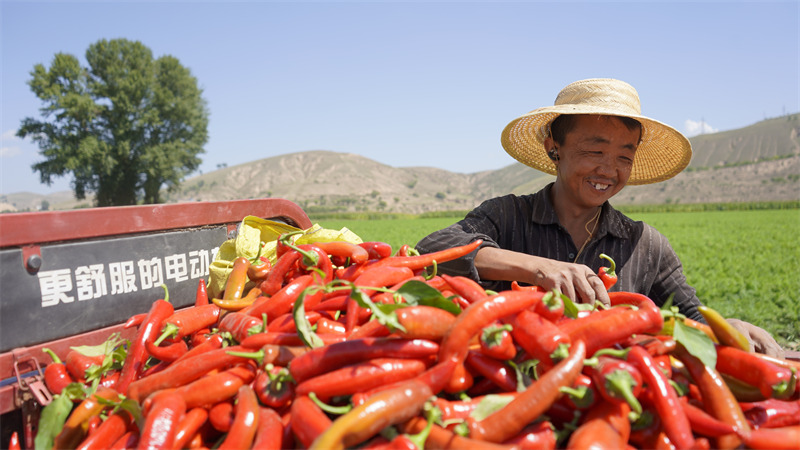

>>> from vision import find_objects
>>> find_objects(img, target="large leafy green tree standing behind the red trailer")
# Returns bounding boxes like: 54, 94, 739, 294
17, 39, 208, 206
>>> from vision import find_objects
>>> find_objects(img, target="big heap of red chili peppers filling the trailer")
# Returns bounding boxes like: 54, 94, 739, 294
21, 239, 800, 449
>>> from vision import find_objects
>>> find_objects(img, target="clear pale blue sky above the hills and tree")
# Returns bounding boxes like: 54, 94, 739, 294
0, 0, 800, 194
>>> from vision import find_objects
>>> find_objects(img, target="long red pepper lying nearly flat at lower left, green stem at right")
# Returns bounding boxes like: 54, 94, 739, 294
128, 347, 247, 402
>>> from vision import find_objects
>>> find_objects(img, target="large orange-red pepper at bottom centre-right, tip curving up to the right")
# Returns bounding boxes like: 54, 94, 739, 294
467, 340, 586, 442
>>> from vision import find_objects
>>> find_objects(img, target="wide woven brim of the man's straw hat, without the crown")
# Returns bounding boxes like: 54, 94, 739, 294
500, 105, 692, 185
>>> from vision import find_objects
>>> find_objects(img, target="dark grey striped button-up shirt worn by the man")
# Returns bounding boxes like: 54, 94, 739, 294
416, 184, 705, 322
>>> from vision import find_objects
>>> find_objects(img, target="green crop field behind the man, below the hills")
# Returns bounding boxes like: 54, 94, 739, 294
319, 209, 800, 350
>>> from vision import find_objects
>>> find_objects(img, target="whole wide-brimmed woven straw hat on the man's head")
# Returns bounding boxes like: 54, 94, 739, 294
500, 78, 692, 185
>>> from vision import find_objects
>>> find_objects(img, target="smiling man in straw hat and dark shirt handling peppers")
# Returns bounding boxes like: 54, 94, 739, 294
417, 79, 783, 356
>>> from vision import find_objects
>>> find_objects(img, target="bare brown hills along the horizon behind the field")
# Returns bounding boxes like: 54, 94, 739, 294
6, 114, 800, 213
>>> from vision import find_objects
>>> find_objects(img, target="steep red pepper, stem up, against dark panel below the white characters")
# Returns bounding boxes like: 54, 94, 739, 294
116, 286, 174, 396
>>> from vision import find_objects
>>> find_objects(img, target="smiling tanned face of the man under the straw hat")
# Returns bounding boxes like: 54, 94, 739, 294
550, 116, 639, 207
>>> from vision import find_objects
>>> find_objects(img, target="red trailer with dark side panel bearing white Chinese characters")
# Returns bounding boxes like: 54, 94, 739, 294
0, 198, 311, 448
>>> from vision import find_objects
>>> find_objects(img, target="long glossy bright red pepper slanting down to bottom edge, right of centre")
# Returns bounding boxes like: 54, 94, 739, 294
628, 346, 695, 449
